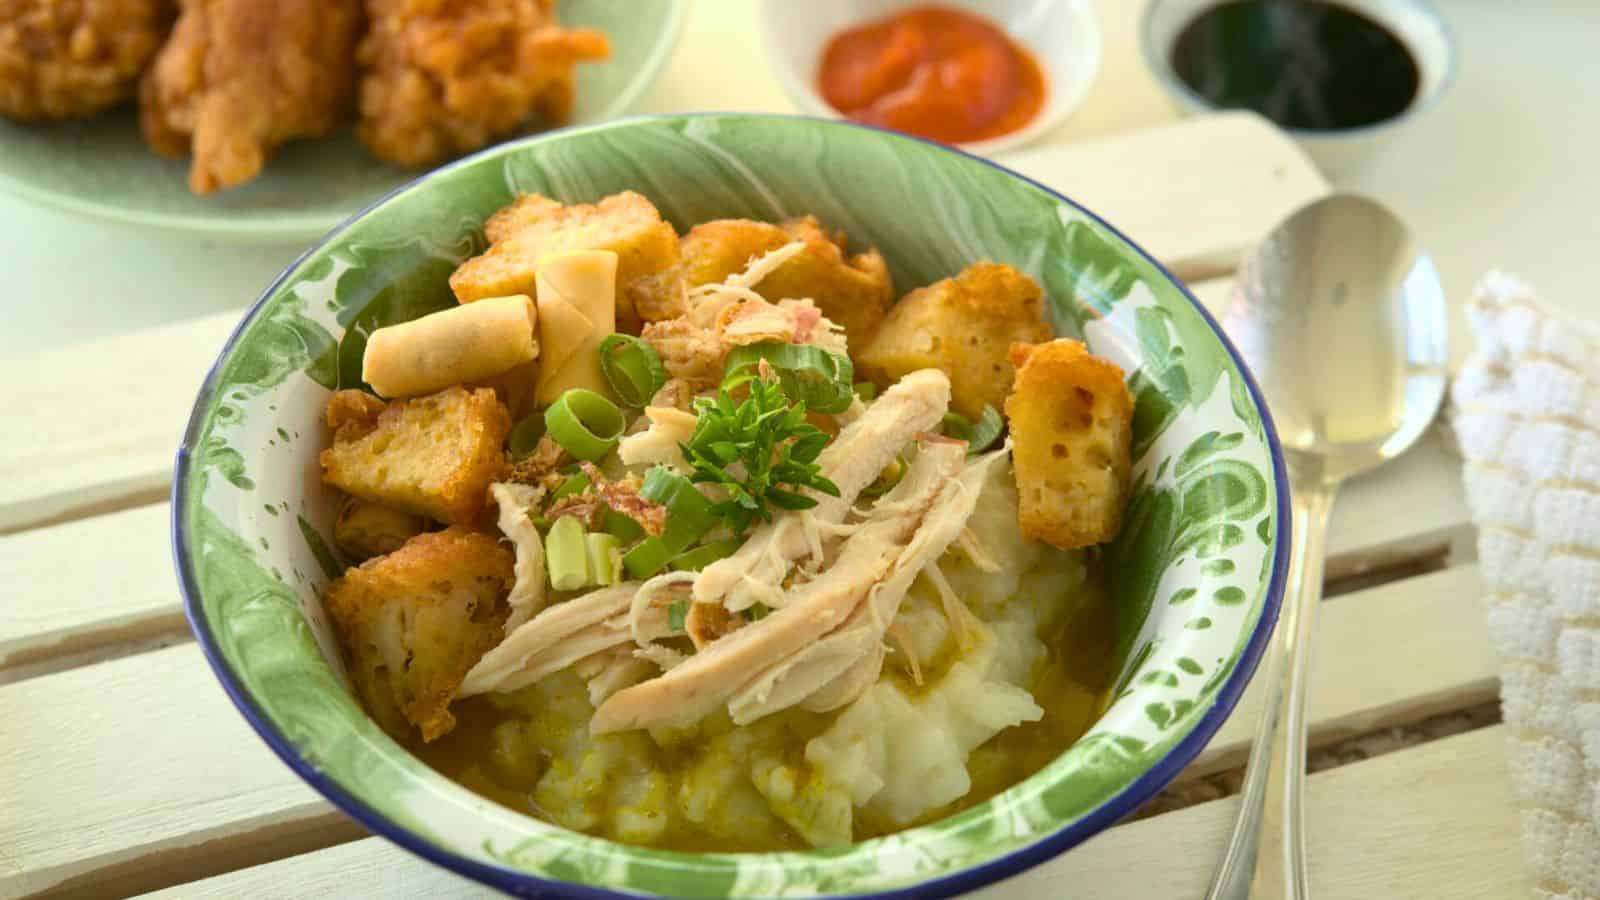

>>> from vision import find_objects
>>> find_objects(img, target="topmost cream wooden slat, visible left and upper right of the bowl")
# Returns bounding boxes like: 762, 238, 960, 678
0, 115, 1326, 533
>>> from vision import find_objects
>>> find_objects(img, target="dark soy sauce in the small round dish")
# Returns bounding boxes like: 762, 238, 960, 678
1173, 0, 1421, 131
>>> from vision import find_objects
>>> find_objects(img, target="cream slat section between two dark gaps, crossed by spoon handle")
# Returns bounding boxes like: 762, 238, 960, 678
1182, 565, 1499, 778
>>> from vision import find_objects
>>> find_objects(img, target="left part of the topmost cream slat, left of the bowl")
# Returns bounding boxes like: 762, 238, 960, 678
0, 309, 240, 535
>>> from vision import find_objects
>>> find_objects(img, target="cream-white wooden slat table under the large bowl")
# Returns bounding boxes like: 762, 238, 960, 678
0, 0, 1548, 898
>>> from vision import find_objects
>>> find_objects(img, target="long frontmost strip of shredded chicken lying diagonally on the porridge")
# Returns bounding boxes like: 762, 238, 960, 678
589, 438, 963, 733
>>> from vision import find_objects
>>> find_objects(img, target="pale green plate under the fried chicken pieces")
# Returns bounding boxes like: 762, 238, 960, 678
0, 0, 688, 242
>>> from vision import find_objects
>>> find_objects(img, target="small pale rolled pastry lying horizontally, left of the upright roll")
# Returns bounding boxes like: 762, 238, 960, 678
362, 295, 539, 397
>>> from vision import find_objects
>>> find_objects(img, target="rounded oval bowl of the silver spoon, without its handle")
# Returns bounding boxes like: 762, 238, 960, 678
1222, 194, 1450, 479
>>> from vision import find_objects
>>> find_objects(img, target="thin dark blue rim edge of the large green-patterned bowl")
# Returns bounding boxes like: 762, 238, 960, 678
170, 112, 1293, 900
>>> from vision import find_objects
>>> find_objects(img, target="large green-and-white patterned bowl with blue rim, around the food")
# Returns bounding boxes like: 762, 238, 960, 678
173, 114, 1288, 897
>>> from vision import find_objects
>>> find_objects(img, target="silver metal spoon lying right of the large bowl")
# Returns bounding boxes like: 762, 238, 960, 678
1206, 194, 1450, 900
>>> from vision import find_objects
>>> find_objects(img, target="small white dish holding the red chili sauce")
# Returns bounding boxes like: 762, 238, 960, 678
762, 0, 1101, 154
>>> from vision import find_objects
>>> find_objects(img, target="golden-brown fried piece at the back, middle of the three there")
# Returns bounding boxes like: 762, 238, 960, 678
682, 216, 894, 348
